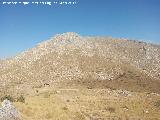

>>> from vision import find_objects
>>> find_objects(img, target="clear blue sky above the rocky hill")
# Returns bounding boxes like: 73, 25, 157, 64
0, 0, 160, 58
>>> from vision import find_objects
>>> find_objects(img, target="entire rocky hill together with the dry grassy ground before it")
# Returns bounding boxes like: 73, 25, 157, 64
0, 32, 160, 120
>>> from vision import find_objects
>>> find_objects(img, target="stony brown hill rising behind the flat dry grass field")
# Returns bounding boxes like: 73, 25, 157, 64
0, 32, 160, 95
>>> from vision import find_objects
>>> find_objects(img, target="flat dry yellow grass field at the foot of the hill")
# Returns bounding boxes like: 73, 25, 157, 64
12, 88, 160, 120
